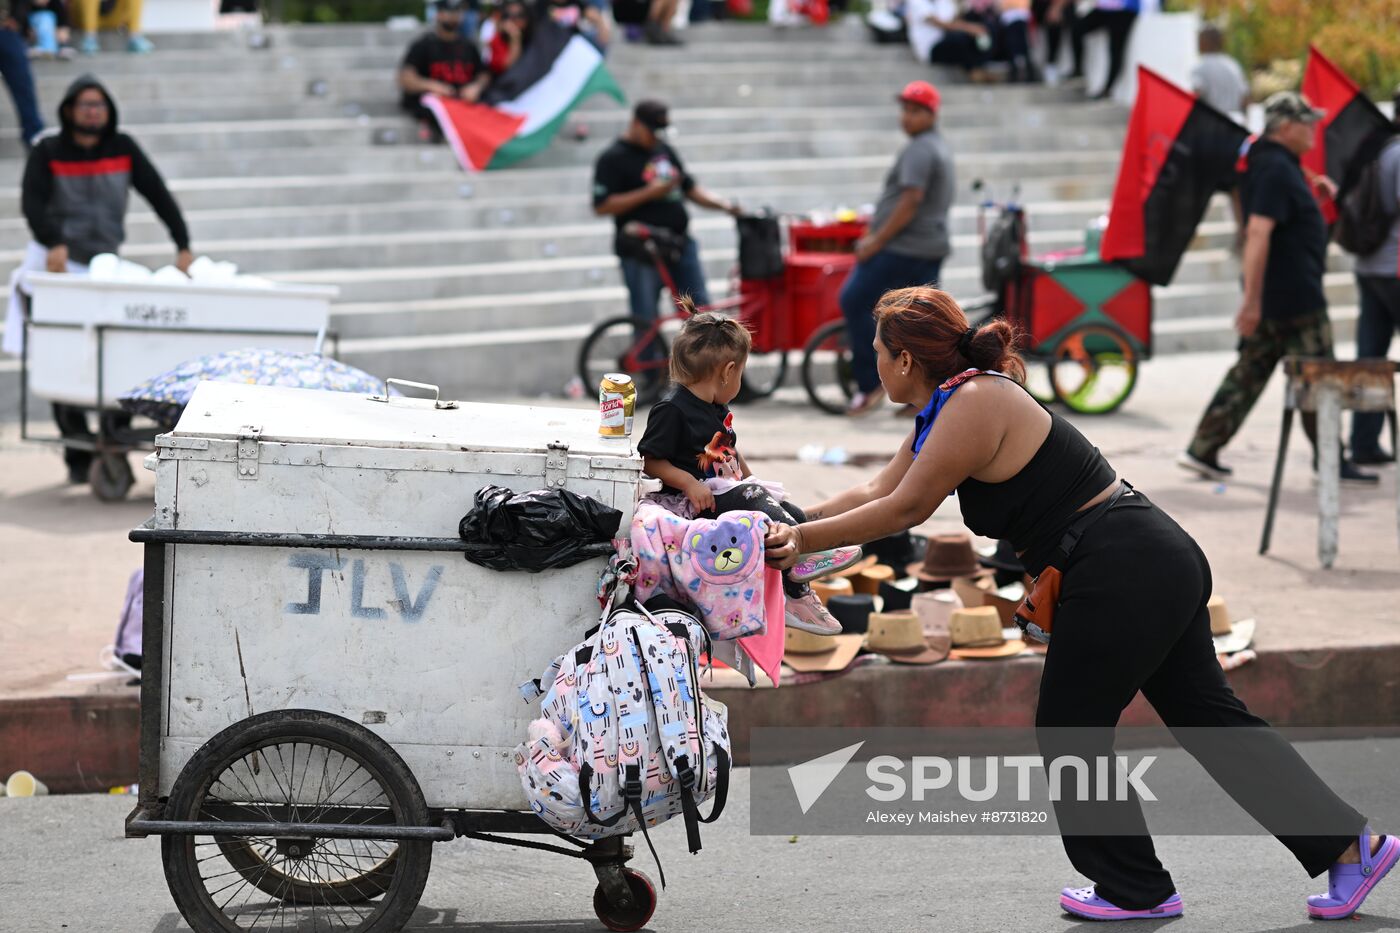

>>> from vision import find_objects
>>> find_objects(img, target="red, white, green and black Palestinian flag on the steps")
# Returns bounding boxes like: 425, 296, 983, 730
423, 20, 626, 171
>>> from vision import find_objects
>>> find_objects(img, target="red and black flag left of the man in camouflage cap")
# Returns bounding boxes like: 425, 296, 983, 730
1099, 66, 1247, 286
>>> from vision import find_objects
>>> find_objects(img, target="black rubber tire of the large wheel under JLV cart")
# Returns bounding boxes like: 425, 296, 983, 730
161, 709, 433, 933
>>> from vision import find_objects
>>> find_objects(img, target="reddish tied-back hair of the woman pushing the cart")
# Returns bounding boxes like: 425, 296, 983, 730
875, 286, 1026, 385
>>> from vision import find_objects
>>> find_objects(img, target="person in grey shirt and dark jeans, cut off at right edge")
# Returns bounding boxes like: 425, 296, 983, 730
1351, 87, 1400, 464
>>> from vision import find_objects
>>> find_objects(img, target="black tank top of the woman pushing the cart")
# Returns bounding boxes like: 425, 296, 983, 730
958, 412, 1116, 576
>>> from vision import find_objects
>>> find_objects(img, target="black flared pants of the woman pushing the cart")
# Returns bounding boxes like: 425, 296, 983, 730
1036, 495, 1365, 909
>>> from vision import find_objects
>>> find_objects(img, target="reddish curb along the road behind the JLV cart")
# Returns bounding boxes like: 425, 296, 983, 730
0, 644, 1400, 794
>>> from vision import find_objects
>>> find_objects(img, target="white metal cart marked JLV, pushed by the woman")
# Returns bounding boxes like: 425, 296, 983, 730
126, 382, 655, 933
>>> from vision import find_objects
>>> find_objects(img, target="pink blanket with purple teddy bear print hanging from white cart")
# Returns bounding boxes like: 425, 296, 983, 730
631, 502, 771, 639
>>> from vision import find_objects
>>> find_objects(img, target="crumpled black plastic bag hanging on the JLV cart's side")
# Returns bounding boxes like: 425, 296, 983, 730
458, 486, 622, 573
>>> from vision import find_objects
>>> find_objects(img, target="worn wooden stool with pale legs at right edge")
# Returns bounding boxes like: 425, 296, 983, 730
1259, 356, 1400, 567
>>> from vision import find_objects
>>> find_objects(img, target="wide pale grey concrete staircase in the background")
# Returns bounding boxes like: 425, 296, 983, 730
0, 24, 1354, 396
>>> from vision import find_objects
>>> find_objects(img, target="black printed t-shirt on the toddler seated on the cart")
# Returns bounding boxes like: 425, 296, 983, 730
637, 385, 739, 492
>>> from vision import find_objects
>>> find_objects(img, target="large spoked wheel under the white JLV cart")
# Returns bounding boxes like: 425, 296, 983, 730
161, 710, 433, 933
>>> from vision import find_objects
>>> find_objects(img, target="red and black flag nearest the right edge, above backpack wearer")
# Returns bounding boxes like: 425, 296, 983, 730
1299, 48, 1392, 224
